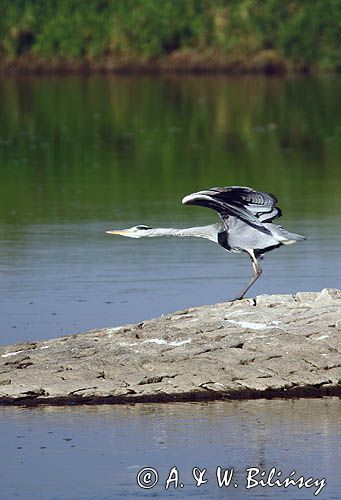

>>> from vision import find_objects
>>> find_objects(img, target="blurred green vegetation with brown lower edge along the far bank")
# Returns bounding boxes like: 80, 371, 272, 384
0, 0, 341, 71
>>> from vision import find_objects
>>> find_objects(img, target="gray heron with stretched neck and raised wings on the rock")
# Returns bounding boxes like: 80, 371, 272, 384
106, 186, 306, 300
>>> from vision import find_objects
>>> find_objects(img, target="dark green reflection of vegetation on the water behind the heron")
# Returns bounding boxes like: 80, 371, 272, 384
0, 77, 341, 225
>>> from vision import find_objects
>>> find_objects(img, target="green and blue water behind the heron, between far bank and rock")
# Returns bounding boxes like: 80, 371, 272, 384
0, 77, 341, 344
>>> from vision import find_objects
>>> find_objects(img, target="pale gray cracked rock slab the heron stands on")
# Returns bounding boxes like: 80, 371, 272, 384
0, 289, 341, 405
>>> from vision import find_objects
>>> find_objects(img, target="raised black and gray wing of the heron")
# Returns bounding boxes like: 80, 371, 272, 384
182, 186, 282, 229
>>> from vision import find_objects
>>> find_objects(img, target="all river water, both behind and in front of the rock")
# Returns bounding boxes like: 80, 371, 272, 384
0, 76, 341, 499
